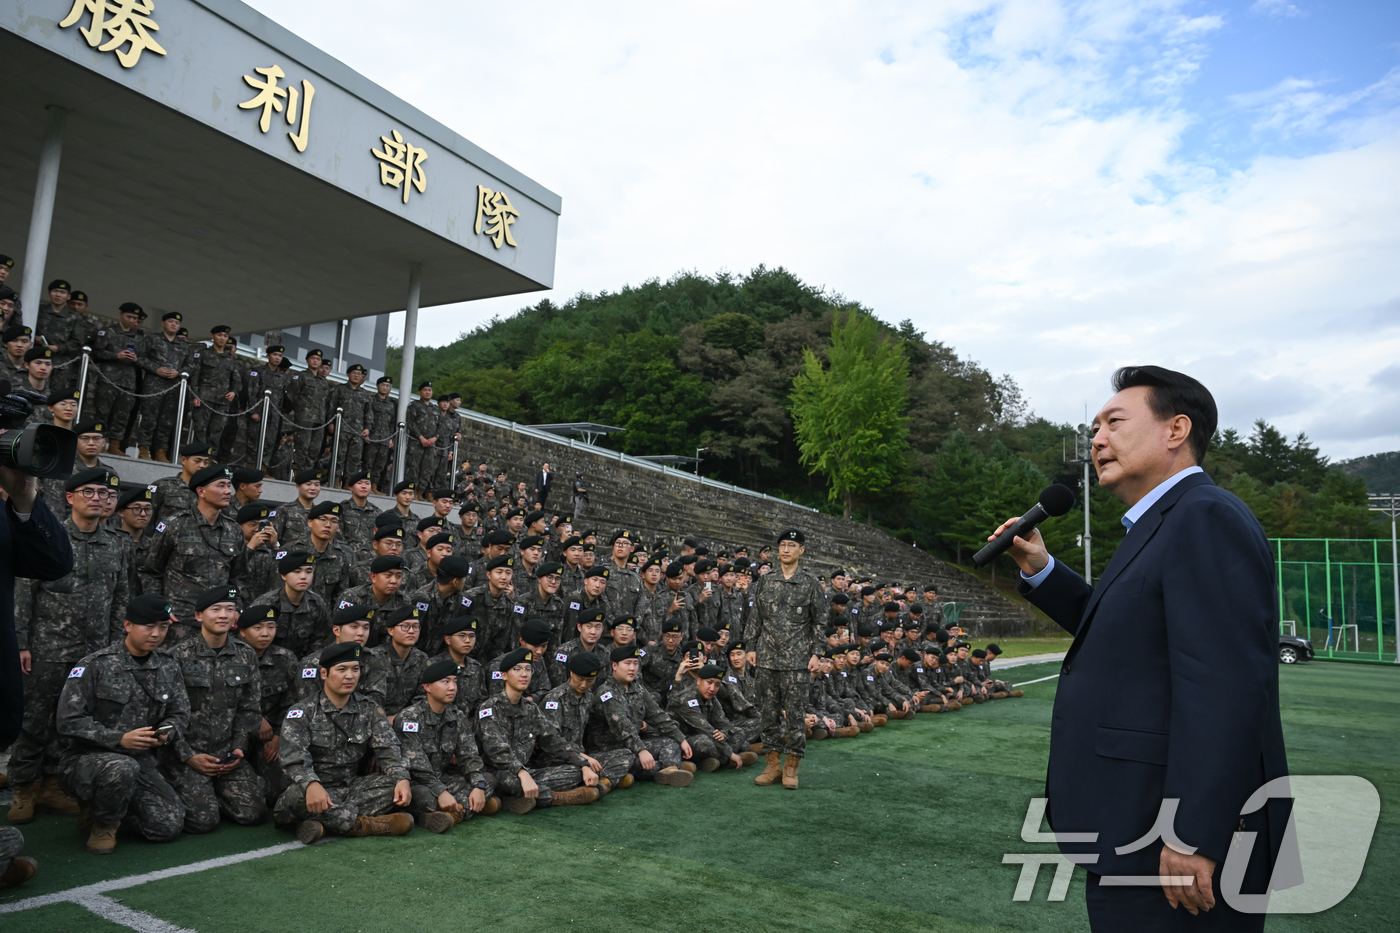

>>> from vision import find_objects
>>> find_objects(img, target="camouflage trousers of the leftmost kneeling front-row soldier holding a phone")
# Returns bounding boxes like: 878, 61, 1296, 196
62, 752, 185, 842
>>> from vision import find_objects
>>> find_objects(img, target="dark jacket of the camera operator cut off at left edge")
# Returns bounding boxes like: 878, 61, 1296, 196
0, 496, 75, 748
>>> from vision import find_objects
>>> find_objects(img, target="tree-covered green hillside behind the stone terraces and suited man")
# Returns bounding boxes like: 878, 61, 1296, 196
389, 266, 1375, 570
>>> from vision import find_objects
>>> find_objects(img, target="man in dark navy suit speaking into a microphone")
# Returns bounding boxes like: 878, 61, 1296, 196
998, 366, 1289, 933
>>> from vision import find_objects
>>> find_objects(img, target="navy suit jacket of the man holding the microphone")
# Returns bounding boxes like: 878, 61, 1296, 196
1021, 474, 1288, 874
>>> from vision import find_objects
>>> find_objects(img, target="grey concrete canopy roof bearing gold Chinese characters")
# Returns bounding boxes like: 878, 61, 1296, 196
0, 0, 560, 339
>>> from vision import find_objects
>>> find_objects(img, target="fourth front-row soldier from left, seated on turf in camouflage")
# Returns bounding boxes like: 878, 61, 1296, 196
395, 660, 500, 832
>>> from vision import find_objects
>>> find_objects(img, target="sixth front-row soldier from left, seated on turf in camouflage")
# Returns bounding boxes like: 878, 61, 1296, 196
584, 644, 694, 787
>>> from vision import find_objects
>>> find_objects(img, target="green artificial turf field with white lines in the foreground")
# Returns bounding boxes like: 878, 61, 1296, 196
0, 663, 1400, 933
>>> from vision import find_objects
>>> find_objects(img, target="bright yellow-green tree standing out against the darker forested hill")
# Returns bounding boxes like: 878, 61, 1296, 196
791, 308, 909, 518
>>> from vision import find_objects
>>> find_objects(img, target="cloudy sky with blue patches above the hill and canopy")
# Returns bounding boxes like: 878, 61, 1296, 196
252, 0, 1400, 458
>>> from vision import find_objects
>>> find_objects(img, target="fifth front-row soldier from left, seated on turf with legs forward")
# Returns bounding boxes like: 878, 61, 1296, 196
476, 649, 602, 814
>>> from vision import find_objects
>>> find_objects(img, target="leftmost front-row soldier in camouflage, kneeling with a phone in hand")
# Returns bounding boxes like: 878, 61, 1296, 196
57, 593, 189, 855
